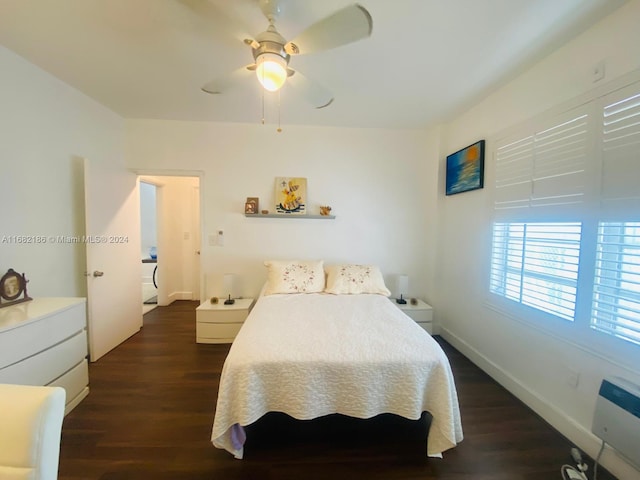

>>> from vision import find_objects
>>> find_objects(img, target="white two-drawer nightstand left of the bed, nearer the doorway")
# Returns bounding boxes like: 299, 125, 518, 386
196, 298, 253, 343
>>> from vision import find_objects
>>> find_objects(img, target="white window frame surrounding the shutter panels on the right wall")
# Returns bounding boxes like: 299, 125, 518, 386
484, 72, 640, 372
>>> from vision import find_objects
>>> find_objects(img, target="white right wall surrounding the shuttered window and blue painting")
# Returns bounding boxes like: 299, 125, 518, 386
434, 0, 640, 479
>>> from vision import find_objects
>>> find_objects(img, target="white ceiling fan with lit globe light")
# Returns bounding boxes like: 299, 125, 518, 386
202, 0, 373, 108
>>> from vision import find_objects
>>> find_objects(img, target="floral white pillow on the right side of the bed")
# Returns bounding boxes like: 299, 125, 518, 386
324, 265, 391, 296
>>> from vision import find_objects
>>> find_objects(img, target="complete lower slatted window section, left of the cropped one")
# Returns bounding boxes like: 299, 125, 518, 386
490, 223, 581, 321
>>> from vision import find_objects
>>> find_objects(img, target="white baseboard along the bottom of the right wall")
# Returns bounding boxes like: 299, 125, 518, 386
439, 326, 640, 480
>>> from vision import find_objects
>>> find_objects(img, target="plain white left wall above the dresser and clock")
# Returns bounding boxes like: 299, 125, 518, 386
0, 46, 123, 297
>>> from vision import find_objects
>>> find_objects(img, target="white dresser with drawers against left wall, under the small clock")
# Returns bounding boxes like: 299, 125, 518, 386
0, 298, 89, 413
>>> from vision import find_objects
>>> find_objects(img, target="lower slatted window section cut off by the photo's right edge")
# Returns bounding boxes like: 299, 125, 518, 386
591, 222, 640, 344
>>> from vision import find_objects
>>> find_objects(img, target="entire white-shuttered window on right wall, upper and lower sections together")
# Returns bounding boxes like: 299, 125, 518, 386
488, 80, 640, 356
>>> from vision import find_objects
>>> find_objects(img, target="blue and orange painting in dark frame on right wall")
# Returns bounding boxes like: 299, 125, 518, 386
446, 140, 484, 195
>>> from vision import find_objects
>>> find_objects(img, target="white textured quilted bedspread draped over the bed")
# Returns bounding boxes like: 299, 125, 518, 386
211, 294, 462, 458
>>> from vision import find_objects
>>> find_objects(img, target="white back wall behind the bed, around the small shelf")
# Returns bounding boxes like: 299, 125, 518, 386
126, 120, 438, 300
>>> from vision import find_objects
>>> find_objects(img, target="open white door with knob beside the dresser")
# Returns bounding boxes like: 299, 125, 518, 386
84, 159, 142, 362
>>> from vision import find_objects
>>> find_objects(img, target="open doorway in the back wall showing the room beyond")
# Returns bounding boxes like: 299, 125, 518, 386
138, 174, 201, 313
